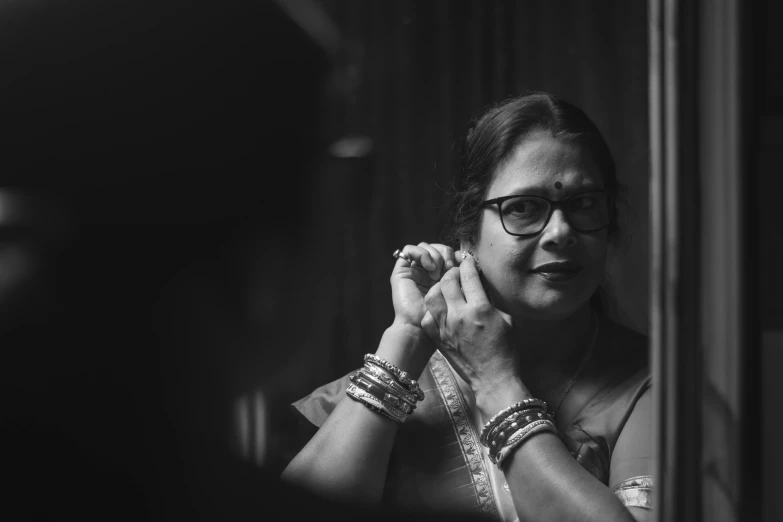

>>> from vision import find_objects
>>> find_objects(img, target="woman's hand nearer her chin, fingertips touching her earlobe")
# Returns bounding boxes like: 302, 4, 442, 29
422, 252, 517, 393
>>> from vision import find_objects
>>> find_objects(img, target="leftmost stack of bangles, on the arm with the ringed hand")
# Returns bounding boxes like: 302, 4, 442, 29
346, 353, 424, 423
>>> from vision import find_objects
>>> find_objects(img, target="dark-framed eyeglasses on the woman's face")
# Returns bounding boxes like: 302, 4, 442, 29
481, 191, 611, 237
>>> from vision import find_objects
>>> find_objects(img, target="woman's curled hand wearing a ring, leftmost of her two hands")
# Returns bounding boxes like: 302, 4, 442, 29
391, 243, 458, 328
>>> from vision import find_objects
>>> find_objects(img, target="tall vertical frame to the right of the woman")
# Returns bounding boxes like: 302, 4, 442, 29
648, 0, 761, 522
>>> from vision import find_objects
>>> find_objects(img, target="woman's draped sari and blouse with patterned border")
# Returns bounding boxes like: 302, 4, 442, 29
293, 319, 653, 521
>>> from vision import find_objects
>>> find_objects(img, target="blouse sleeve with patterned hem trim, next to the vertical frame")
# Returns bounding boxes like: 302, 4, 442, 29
609, 388, 653, 509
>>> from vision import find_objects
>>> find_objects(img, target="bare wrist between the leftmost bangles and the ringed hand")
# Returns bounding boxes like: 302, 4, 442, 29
375, 323, 435, 380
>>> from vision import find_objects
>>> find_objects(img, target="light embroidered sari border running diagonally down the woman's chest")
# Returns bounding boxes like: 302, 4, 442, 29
430, 352, 500, 520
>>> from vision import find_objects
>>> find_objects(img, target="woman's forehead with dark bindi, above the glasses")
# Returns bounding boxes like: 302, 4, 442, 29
487, 132, 603, 199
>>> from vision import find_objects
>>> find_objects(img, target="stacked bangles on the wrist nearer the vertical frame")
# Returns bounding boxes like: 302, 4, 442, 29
479, 399, 557, 471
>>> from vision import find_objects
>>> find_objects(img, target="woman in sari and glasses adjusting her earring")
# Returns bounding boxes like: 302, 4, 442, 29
283, 93, 652, 522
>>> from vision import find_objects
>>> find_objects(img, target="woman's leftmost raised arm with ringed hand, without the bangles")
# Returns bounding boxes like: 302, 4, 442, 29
282, 243, 455, 503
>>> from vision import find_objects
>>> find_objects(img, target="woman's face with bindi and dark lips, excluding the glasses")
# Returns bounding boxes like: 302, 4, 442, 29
463, 132, 608, 319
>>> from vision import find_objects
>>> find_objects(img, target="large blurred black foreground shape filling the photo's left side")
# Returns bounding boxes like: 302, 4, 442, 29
0, 0, 358, 520
